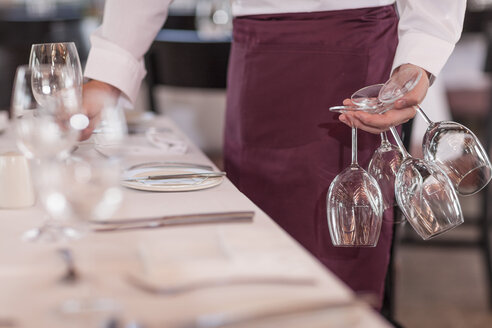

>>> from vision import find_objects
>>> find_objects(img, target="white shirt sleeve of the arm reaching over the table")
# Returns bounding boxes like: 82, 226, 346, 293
84, 0, 171, 103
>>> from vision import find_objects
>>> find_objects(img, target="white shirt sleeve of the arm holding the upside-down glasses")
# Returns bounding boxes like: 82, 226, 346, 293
392, 0, 466, 76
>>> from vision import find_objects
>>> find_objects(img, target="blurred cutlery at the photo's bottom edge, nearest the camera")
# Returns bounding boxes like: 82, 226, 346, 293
178, 298, 367, 328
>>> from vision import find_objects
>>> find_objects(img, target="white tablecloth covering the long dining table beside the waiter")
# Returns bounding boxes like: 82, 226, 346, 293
0, 117, 389, 328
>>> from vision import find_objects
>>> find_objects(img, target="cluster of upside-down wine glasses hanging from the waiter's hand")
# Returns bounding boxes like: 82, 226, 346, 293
327, 68, 492, 246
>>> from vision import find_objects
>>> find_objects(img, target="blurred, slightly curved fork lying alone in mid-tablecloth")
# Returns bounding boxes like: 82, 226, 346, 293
126, 275, 316, 296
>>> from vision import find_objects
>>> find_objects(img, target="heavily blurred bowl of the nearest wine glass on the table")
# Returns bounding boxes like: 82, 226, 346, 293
33, 152, 123, 241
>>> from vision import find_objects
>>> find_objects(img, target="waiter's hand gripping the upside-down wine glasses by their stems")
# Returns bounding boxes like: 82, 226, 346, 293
338, 64, 429, 134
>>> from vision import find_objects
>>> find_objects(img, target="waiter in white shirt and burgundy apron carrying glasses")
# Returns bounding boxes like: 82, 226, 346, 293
84, 0, 466, 312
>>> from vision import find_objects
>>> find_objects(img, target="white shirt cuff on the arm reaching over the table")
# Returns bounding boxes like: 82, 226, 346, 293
84, 30, 146, 103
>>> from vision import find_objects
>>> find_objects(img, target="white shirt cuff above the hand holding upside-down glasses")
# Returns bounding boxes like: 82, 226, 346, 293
391, 33, 454, 76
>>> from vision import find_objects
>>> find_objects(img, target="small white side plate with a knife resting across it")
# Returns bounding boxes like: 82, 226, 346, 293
121, 165, 224, 191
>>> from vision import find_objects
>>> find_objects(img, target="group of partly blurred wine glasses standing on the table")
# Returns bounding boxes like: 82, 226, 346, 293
11, 42, 126, 241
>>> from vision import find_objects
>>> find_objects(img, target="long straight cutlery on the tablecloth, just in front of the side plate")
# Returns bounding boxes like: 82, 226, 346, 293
90, 211, 255, 232
